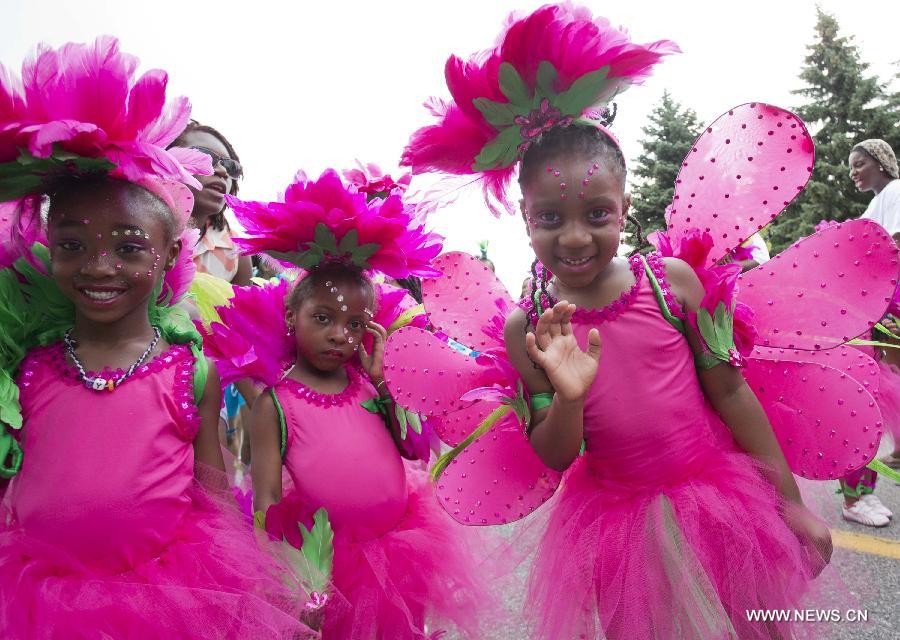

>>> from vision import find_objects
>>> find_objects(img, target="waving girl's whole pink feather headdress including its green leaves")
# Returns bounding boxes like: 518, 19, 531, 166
401, 3, 680, 215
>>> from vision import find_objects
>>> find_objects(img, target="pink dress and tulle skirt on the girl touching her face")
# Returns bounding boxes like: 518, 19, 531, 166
266, 367, 482, 640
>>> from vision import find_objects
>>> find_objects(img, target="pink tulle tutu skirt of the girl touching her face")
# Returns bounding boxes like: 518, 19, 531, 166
266, 470, 495, 640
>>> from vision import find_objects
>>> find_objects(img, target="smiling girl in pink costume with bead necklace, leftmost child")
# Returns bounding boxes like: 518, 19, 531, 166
0, 38, 317, 640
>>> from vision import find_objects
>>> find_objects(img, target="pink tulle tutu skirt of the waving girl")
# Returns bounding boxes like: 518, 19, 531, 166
526, 451, 821, 640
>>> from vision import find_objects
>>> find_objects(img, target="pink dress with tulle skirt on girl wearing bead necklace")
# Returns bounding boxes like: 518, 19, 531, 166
0, 344, 314, 640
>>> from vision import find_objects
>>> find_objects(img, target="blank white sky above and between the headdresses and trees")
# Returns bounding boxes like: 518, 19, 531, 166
0, 0, 900, 293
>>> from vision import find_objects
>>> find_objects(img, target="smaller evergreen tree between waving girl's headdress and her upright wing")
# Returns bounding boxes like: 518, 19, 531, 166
629, 91, 699, 242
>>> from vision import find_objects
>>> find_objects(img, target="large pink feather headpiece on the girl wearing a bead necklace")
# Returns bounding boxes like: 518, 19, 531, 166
0, 36, 212, 229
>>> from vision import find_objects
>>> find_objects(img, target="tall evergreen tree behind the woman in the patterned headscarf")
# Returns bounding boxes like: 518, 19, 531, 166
768, 9, 900, 252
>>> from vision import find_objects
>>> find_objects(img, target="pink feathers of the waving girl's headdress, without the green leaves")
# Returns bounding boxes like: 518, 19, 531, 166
401, 4, 679, 215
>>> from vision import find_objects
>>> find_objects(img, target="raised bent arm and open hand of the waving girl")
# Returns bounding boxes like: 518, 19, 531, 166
504, 302, 600, 471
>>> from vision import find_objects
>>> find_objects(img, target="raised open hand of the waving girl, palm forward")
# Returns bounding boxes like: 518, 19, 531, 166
525, 301, 600, 400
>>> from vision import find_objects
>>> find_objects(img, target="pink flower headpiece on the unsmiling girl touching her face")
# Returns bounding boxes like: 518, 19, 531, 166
225, 169, 443, 278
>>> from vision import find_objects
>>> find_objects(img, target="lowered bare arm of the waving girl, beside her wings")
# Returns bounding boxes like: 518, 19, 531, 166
665, 258, 831, 562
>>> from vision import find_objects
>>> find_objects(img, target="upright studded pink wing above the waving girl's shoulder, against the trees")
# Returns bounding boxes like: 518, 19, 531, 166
666, 102, 815, 264
